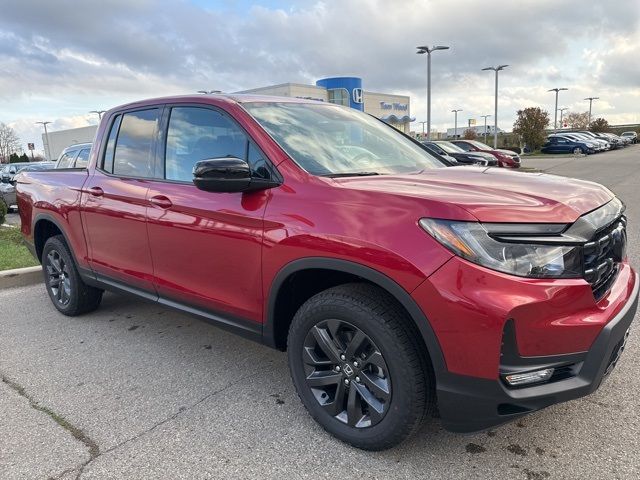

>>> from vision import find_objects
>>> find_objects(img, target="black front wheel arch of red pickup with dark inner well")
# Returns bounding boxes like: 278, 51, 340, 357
262, 257, 446, 375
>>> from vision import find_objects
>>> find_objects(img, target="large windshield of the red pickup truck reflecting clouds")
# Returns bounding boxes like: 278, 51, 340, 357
243, 102, 445, 176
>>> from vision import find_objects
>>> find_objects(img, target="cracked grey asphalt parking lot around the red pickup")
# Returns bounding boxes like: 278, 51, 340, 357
0, 145, 640, 480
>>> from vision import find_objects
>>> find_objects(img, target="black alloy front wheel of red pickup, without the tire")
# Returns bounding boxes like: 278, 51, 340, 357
302, 319, 391, 428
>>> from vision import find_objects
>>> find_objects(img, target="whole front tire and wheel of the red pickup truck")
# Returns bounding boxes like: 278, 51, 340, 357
288, 283, 436, 450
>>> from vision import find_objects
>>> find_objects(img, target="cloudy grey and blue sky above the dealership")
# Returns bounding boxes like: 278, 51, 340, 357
0, 0, 640, 155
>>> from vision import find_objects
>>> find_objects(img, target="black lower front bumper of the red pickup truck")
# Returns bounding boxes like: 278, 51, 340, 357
437, 275, 640, 432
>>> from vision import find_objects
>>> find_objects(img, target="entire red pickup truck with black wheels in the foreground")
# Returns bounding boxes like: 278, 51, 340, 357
17, 95, 639, 450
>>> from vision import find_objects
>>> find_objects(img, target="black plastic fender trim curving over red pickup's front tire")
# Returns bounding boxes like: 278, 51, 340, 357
262, 257, 446, 377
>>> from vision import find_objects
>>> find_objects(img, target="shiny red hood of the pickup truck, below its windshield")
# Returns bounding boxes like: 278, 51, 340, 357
335, 167, 614, 223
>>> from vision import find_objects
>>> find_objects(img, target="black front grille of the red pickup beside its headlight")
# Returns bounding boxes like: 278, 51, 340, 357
583, 216, 627, 300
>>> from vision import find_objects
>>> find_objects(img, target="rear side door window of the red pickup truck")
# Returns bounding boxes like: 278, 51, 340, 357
111, 108, 160, 178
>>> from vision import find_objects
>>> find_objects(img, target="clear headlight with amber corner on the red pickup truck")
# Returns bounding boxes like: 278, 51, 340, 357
420, 218, 582, 278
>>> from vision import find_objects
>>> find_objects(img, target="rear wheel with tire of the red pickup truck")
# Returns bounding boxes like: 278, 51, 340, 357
42, 235, 102, 317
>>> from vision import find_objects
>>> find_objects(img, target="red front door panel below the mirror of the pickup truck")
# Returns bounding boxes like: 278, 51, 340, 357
147, 182, 268, 322
